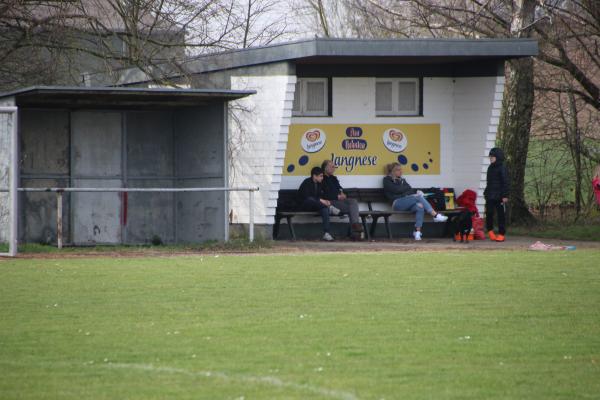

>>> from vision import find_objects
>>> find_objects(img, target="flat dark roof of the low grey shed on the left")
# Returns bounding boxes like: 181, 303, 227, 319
0, 86, 256, 108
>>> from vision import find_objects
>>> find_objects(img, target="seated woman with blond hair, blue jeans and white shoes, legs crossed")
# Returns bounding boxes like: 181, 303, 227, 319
383, 163, 448, 240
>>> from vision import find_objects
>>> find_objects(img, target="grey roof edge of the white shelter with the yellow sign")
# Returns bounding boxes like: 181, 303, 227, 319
99, 38, 538, 85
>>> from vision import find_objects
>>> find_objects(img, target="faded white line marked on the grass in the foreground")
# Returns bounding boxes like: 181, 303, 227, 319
105, 363, 358, 400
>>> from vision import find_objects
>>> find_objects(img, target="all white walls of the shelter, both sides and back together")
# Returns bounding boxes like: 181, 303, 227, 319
229, 75, 504, 224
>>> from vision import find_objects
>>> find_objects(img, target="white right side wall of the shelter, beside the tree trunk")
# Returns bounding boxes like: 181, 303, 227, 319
452, 77, 504, 212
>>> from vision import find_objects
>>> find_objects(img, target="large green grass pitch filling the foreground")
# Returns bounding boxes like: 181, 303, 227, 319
0, 250, 600, 400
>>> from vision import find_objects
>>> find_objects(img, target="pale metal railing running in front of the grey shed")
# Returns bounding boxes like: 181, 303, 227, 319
0, 187, 259, 256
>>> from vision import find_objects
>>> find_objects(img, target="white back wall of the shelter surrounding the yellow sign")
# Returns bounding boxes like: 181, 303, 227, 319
281, 77, 454, 189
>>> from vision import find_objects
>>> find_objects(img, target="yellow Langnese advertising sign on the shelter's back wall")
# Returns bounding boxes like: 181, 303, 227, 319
283, 124, 440, 176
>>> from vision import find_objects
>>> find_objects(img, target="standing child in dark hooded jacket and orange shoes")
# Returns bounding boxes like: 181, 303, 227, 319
483, 147, 510, 242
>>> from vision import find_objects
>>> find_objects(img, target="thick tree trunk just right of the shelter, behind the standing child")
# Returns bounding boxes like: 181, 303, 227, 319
498, 0, 535, 223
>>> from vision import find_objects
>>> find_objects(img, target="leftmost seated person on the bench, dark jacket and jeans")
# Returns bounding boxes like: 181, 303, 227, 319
298, 167, 340, 242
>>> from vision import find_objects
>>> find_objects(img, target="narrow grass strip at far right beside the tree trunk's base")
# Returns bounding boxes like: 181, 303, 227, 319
509, 222, 600, 242
